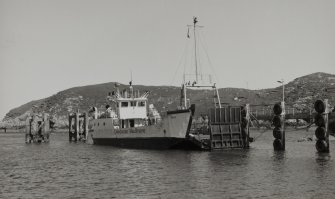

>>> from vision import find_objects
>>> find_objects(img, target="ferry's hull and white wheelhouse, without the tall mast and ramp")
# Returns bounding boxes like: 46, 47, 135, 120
91, 84, 207, 149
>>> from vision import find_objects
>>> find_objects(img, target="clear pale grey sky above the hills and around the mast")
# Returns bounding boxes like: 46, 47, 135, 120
0, 0, 335, 119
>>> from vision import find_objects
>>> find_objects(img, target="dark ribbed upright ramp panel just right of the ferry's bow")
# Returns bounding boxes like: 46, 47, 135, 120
209, 106, 246, 150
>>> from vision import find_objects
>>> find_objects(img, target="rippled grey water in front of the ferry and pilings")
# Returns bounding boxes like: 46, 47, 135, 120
0, 132, 335, 198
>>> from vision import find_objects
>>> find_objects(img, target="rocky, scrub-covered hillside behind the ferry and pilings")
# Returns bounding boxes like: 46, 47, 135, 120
2, 73, 335, 127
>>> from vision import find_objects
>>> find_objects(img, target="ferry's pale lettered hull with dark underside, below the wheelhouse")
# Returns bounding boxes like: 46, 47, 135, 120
91, 109, 206, 149
